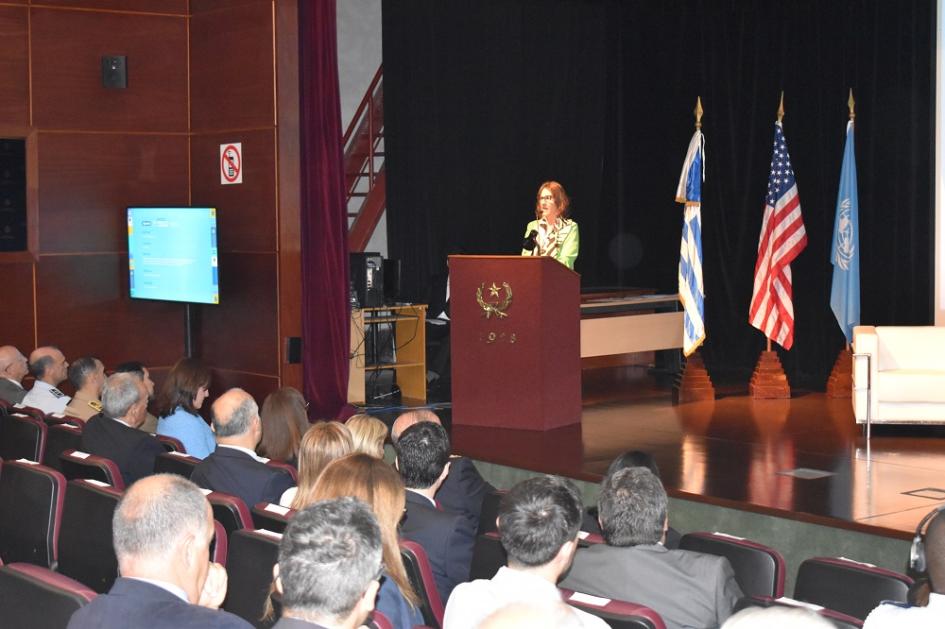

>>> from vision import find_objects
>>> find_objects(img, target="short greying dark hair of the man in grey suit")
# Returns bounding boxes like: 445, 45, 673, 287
598, 467, 667, 546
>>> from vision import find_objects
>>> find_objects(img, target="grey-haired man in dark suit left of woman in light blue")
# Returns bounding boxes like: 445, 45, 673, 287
82, 373, 164, 486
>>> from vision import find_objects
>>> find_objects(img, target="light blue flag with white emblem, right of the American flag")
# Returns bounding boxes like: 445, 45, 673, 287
830, 120, 860, 343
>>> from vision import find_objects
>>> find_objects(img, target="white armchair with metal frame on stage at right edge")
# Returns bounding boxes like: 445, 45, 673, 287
853, 325, 945, 424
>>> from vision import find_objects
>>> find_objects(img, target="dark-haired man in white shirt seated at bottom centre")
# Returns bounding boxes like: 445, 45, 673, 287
443, 476, 607, 629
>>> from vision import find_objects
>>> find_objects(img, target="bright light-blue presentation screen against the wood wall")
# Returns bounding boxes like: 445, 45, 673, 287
128, 207, 220, 304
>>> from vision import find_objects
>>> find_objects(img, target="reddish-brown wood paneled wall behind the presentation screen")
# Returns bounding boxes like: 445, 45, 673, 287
0, 0, 302, 402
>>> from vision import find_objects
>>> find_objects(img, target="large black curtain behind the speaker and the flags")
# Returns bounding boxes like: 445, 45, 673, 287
383, 0, 935, 389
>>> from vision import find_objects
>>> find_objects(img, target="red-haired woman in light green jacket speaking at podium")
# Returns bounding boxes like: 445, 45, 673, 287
522, 181, 581, 271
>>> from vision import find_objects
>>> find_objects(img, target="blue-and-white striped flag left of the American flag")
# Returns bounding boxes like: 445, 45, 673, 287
676, 129, 705, 356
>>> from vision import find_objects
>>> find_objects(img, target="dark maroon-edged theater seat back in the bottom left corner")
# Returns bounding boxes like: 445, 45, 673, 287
0, 563, 96, 629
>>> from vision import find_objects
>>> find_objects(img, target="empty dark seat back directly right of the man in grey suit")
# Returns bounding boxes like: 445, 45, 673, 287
679, 532, 786, 598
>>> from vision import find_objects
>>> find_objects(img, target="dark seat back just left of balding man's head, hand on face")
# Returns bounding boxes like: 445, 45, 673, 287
57, 479, 121, 594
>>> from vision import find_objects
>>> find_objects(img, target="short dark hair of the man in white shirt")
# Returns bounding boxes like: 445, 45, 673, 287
499, 476, 582, 566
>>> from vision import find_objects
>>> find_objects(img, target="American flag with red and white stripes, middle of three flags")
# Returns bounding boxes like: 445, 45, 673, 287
748, 121, 807, 349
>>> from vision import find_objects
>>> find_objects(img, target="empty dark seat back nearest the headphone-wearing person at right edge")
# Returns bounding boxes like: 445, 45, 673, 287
794, 557, 912, 620
